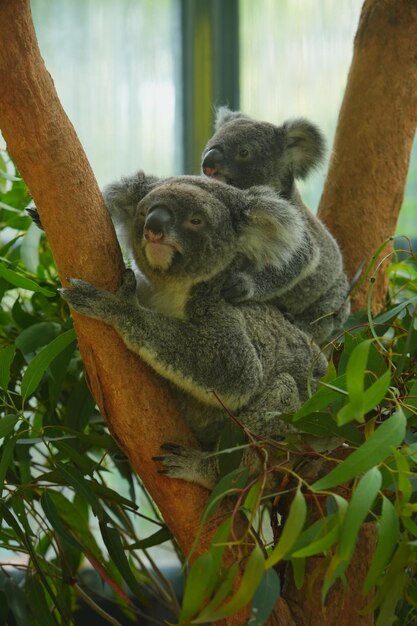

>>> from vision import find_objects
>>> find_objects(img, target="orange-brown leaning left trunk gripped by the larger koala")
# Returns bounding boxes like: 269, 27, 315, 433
0, 0, 250, 624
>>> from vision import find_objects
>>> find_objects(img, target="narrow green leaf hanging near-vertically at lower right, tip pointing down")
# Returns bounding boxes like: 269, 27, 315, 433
363, 496, 400, 595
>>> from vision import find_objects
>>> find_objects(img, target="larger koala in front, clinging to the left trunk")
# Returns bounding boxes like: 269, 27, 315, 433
61, 173, 327, 488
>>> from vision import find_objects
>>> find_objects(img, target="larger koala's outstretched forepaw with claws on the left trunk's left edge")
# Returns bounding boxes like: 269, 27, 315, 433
58, 278, 114, 320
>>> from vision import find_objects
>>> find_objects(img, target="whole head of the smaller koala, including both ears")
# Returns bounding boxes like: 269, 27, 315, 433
202, 107, 325, 197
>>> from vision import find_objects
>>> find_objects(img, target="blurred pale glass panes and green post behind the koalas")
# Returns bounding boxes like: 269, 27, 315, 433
13, 0, 417, 236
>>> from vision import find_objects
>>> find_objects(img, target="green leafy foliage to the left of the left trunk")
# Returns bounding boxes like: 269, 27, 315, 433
0, 152, 179, 626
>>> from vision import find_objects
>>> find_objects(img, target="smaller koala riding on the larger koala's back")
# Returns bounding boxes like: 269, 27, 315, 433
201, 107, 350, 345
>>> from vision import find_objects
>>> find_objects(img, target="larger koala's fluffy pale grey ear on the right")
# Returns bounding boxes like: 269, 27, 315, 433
238, 187, 306, 269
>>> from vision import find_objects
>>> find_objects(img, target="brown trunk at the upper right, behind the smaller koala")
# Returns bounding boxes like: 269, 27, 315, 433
318, 0, 417, 310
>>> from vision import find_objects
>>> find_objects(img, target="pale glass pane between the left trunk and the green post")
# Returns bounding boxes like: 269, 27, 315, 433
32, 0, 181, 185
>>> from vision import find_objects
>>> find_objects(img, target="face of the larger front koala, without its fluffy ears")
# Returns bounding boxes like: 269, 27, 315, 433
132, 177, 247, 280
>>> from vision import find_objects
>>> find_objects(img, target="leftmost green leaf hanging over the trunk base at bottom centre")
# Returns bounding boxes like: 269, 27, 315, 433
180, 552, 217, 622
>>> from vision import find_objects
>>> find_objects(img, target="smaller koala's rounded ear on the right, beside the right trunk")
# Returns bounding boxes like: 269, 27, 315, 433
280, 118, 326, 178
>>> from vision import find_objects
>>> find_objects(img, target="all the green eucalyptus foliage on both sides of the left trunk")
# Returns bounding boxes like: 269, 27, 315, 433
0, 153, 417, 626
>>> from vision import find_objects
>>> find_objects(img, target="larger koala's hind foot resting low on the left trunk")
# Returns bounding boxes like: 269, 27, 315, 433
153, 443, 217, 489
